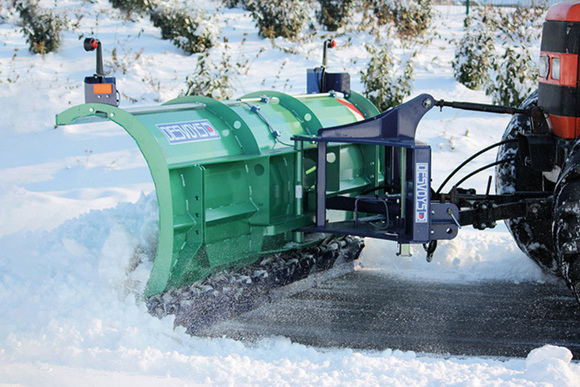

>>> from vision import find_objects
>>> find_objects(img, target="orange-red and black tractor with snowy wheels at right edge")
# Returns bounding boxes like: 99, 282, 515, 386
496, 1, 580, 300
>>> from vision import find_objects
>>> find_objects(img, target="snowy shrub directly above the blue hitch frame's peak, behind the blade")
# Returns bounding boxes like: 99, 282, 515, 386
361, 45, 415, 111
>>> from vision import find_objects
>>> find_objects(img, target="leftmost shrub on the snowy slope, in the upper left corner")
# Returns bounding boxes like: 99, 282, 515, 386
16, 0, 64, 55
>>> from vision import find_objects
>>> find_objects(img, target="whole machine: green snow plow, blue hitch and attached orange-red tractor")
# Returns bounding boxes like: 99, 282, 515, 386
56, 2, 580, 332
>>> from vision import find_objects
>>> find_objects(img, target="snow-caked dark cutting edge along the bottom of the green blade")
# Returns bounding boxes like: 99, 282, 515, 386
147, 236, 364, 334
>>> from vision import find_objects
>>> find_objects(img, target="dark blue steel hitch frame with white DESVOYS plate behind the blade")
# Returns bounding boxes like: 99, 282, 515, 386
294, 94, 459, 244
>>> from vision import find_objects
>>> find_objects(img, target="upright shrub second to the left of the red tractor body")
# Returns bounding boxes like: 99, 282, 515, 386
451, 17, 495, 90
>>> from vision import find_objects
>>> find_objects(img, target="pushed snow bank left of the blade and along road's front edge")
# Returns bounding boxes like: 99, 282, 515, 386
0, 195, 580, 387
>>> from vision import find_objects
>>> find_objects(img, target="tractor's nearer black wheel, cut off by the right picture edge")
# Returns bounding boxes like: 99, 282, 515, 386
553, 141, 580, 302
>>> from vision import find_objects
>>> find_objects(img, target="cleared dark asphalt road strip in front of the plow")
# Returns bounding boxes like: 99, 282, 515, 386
197, 270, 580, 359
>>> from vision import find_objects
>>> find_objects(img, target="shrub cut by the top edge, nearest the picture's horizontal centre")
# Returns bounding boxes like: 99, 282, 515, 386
246, 0, 312, 40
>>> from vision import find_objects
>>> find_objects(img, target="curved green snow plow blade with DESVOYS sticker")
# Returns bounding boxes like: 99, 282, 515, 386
56, 91, 381, 297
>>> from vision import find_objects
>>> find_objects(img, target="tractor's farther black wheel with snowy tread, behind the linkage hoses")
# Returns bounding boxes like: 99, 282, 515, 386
495, 91, 558, 274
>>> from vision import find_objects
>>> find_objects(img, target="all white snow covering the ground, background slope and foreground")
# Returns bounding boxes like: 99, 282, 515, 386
0, 0, 580, 386
